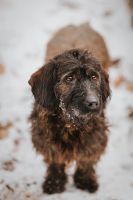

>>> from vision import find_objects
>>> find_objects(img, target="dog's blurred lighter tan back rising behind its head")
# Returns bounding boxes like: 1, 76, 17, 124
45, 23, 110, 68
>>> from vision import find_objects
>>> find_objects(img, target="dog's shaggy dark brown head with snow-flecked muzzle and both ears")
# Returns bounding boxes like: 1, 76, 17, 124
29, 49, 110, 122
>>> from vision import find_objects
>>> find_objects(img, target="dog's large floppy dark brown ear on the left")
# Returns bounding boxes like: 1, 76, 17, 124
29, 62, 56, 109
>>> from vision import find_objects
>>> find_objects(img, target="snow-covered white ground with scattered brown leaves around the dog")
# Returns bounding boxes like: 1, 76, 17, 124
0, 0, 133, 200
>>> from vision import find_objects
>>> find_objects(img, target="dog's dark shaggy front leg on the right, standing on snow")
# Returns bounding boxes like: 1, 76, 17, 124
73, 161, 98, 193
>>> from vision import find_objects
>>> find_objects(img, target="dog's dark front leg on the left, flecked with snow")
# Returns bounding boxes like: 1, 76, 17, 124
43, 163, 67, 194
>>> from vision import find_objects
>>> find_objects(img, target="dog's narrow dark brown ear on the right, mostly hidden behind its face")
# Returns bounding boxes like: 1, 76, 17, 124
101, 70, 111, 103
